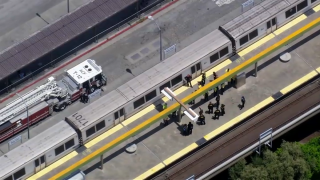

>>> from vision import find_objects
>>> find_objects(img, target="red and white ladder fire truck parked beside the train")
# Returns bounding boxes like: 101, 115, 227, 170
0, 59, 107, 142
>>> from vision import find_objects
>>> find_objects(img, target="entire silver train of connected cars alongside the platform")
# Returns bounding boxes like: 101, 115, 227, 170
0, 0, 320, 180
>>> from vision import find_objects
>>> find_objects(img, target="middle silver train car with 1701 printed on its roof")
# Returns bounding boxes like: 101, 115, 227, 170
66, 30, 231, 143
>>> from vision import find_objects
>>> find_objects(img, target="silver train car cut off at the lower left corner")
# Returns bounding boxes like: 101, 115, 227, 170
0, 121, 79, 180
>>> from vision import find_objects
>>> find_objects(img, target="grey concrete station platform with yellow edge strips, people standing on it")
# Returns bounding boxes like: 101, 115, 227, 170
29, 6, 320, 179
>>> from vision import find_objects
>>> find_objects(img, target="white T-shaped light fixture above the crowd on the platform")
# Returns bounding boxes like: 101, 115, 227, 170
161, 87, 199, 123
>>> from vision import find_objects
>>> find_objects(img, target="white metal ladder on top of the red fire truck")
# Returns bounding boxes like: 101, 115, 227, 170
0, 77, 61, 125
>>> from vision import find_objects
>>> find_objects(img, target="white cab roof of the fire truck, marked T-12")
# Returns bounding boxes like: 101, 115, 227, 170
67, 59, 102, 84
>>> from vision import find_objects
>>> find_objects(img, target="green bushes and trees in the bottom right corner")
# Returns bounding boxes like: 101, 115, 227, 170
229, 137, 320, 180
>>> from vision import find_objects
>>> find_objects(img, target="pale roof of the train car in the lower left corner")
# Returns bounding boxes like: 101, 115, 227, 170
0, 121, 76, 178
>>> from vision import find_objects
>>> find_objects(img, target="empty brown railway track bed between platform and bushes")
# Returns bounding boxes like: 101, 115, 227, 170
150, 79, 320, 180
